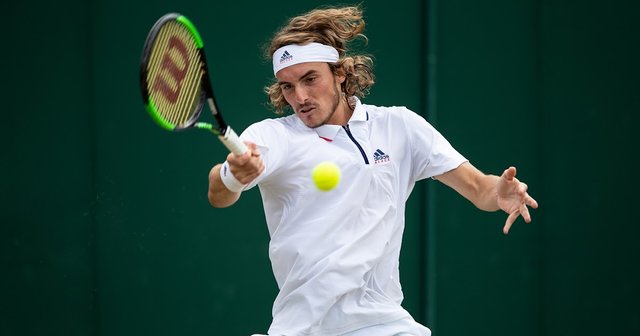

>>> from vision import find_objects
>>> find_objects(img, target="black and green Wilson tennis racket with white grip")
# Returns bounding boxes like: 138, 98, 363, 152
140, 13, 247, 154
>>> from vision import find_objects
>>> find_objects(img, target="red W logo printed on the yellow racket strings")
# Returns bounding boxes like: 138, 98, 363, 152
153, 36, 189, 103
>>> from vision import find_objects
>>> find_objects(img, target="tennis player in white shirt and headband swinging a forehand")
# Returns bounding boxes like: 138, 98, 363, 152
208, 7, 538, 336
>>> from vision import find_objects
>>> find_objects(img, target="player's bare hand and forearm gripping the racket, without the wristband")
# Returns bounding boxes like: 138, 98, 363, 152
208, 142, 264, 208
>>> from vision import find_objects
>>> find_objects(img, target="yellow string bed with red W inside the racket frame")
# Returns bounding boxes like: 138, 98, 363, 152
147, 21, 204, 126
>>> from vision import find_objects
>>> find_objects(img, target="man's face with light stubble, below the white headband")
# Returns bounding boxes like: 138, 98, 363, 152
276, 62, 348, 128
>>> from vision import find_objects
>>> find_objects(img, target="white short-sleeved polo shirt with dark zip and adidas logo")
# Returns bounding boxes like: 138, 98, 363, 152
241, 101, 466, 336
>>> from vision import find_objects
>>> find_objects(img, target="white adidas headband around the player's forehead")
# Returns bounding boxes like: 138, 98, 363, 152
273, 42, 340, 75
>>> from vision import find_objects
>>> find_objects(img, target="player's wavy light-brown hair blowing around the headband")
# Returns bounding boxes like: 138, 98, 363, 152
264, 6, 375, 114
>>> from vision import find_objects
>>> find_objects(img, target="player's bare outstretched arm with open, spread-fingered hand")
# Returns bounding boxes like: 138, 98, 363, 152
435, 162, 538, 234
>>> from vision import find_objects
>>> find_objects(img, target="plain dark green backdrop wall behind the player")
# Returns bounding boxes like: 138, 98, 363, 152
0, 0, 640, 336
